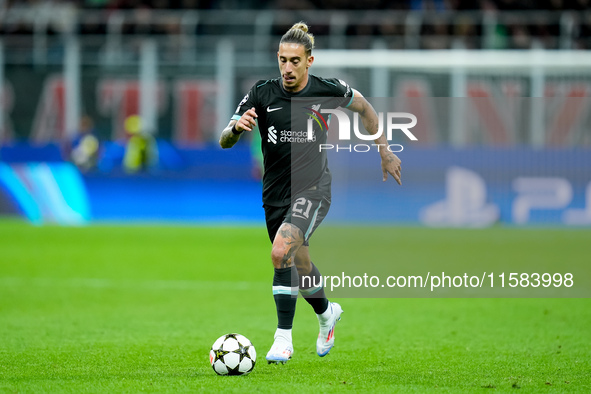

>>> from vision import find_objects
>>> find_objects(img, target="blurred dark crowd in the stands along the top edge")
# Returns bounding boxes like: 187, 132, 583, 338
0, 0, 591, 49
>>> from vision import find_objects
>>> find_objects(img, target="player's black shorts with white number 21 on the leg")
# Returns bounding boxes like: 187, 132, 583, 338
263, 187, 330, 246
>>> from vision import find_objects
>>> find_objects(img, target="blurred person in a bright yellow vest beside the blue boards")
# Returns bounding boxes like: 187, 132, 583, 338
123, 115, 158, 173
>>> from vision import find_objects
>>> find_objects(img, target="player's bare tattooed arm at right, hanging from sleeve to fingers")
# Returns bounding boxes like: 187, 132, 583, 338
347, 90, 402, 185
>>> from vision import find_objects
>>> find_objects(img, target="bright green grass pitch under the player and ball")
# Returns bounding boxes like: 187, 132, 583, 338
0, 220, 591, 393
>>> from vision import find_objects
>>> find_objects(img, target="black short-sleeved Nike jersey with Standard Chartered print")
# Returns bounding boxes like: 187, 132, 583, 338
232, 75, 353, 206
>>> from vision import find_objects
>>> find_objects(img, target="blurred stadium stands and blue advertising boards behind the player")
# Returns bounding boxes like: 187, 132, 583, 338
0, 0, 591, 227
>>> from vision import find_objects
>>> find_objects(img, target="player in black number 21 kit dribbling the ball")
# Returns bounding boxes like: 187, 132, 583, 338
220, 22, 401, 363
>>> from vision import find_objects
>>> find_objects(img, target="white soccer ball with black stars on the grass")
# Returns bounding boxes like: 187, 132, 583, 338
209, 334, 257, 375
